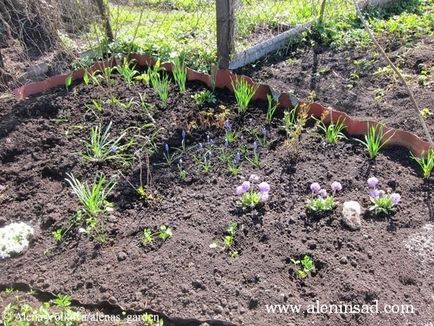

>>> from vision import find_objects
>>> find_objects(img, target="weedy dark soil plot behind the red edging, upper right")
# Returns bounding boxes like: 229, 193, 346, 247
238, 38, 434, 136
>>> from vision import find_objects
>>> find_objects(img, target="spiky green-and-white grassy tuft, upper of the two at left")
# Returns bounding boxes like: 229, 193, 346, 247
83, 122, 131, 163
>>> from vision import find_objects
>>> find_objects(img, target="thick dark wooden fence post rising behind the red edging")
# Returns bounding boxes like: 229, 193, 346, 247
216, 0, 235, 69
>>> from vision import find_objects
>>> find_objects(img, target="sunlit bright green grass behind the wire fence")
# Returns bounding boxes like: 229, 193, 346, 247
74, 0, 434, 71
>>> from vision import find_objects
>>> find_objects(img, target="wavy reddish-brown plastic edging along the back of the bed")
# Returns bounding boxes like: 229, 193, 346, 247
14, 54, 430, 157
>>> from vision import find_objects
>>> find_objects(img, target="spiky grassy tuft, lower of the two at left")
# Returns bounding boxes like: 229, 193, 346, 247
65, 173, 116, 218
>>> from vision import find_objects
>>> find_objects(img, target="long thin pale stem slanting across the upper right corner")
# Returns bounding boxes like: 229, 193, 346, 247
352, 0, 434, 147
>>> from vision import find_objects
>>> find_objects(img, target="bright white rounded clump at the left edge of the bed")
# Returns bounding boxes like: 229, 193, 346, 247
0, 222, 34, 259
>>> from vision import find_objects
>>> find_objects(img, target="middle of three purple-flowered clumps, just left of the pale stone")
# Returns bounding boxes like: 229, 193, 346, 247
306, 181, 342, 214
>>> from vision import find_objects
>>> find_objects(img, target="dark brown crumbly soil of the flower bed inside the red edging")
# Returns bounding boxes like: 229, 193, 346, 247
0, 65, 434, 326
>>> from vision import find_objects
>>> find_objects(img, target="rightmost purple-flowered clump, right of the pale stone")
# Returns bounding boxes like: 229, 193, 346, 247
368, 177, 401, 215
